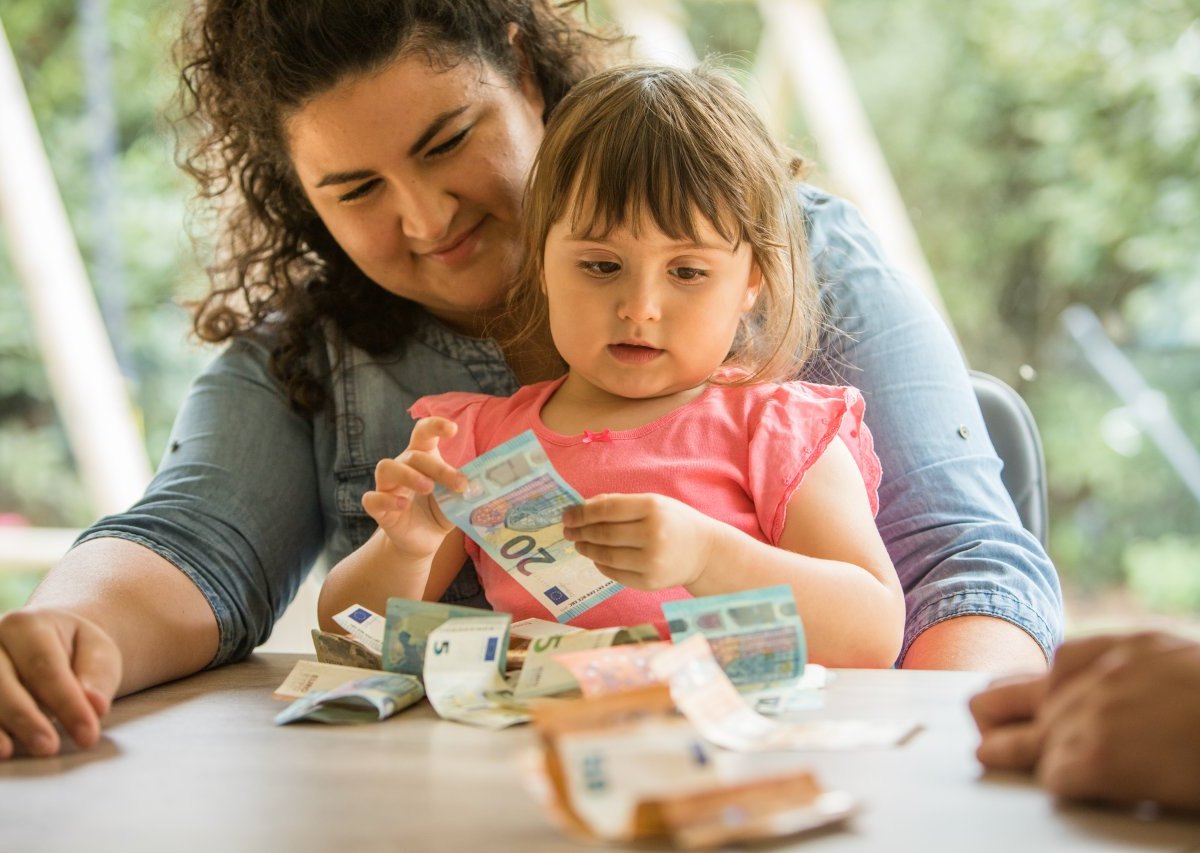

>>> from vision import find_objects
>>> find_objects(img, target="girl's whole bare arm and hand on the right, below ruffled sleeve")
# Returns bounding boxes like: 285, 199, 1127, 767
564, 439, 905, 667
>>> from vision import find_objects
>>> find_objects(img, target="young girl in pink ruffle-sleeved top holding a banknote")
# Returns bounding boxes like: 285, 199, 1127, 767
319, 66, 905, 667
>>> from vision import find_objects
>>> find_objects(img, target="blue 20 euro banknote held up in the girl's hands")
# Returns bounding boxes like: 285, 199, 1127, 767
434, 429, 622, 621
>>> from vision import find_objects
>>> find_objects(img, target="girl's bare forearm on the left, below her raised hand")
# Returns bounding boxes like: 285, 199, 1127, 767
317, 528, 467, 631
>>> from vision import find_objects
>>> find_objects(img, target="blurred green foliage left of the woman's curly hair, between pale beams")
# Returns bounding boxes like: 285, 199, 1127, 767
0, 0, 206, 527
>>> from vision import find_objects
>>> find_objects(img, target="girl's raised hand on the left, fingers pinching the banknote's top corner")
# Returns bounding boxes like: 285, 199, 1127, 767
362, 418, 467, 559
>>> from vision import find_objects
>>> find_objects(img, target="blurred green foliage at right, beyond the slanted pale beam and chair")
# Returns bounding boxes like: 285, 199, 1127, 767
829, 0, 1200, 609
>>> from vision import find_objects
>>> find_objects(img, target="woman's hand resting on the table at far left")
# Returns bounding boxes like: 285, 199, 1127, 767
0, 607, 121, 759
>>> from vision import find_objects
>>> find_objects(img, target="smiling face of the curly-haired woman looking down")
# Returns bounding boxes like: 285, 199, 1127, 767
286, 54, 544, 334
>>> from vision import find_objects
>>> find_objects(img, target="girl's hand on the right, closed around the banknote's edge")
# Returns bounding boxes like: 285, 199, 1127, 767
563, 494, 720, 589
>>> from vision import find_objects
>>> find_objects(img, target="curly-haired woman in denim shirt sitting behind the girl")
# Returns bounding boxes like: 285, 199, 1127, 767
0, 0, 1061, 757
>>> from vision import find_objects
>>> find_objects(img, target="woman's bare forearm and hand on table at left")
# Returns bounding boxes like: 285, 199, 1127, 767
0, 539, 217, 759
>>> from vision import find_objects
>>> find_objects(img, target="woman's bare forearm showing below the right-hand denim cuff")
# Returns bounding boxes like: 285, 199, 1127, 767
901, 615, 1046, 675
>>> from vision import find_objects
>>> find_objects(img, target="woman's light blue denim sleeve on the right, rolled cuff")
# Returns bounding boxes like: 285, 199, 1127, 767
800, 187, 1062, 661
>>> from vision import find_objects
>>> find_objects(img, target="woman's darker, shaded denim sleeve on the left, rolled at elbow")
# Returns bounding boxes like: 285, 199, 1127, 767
79, 338, 325, 666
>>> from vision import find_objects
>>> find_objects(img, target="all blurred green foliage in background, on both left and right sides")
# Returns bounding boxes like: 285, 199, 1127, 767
0, 0, 1200, 609
